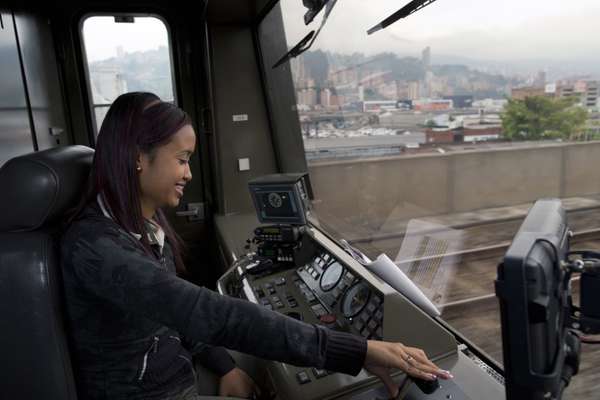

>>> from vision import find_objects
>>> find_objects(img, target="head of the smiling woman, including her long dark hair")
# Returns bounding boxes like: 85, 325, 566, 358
70, 92, 196, 272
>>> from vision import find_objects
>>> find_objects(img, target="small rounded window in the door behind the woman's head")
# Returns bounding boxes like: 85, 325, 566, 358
82, 15, 175, 135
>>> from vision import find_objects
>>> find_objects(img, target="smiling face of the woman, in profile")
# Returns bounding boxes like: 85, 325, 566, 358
137, 125, 196, 218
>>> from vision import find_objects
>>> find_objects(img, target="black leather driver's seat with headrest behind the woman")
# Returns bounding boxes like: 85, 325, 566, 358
0, 146, 94, 400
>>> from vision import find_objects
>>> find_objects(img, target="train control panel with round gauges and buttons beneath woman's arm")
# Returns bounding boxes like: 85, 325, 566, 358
218, 229, 501, 400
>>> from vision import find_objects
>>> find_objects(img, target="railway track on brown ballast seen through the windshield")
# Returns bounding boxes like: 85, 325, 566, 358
344, 208, 600, 400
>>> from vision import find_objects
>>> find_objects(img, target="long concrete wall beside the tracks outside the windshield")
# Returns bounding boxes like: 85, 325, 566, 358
309, 142, 600, 236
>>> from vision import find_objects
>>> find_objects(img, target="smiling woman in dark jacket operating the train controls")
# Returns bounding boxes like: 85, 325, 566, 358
61, 93, 450, 400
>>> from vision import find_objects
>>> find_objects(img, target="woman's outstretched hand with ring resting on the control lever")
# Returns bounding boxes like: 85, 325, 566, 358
365, 340, 453, 398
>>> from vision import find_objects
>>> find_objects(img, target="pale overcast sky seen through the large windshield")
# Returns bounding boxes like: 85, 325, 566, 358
281, 0, 600, 61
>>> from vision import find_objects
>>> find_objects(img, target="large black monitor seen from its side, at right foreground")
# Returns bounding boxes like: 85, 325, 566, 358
495, 199, 570, 400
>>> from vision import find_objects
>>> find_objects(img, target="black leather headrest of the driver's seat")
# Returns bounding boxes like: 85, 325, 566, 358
0, 146, 94, 232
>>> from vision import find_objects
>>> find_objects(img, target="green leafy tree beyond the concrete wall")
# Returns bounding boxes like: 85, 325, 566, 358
501, 96, 588, 140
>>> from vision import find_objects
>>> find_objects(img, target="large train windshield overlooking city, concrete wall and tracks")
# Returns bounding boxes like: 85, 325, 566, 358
259, 0, 600, 390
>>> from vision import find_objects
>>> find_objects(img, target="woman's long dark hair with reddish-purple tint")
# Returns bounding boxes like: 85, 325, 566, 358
73, 92, 191, 274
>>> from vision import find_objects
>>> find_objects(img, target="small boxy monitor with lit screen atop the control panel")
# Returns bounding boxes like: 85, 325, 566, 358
248, 173, 311, 225
